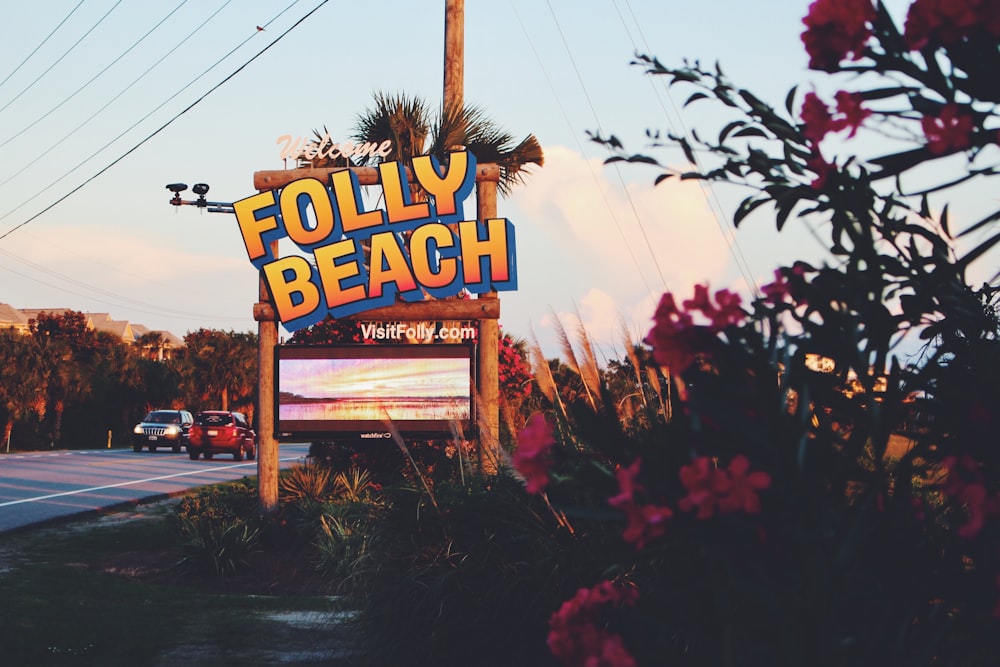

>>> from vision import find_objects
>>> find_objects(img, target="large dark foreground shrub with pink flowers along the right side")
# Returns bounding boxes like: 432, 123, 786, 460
511, 0, 1000, 665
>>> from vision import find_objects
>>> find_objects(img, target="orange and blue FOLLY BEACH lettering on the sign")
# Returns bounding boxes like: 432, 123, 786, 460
233, 151, 517, 331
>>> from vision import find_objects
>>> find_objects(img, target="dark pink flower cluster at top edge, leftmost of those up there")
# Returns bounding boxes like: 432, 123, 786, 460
802, 0, 875, 72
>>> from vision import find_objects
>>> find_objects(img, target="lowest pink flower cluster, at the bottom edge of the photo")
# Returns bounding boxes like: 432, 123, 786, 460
547, 581, 639, 667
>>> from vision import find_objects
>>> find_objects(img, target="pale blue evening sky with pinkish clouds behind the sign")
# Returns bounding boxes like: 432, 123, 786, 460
0, 0, 984, 360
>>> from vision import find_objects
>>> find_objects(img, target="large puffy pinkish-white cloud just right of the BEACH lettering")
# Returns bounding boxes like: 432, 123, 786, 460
500, 146, 748, 355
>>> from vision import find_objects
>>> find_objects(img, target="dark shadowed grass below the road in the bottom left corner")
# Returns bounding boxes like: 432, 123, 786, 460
0, 500, 356, 666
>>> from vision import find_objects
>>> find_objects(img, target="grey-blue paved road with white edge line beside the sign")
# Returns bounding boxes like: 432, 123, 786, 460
0, 443, 309, 533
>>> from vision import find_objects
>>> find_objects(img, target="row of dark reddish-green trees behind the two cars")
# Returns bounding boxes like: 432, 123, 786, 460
0, 311, 257, 451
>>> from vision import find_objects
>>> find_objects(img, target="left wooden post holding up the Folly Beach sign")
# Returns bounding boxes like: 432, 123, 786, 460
253, 241, 278, 514
